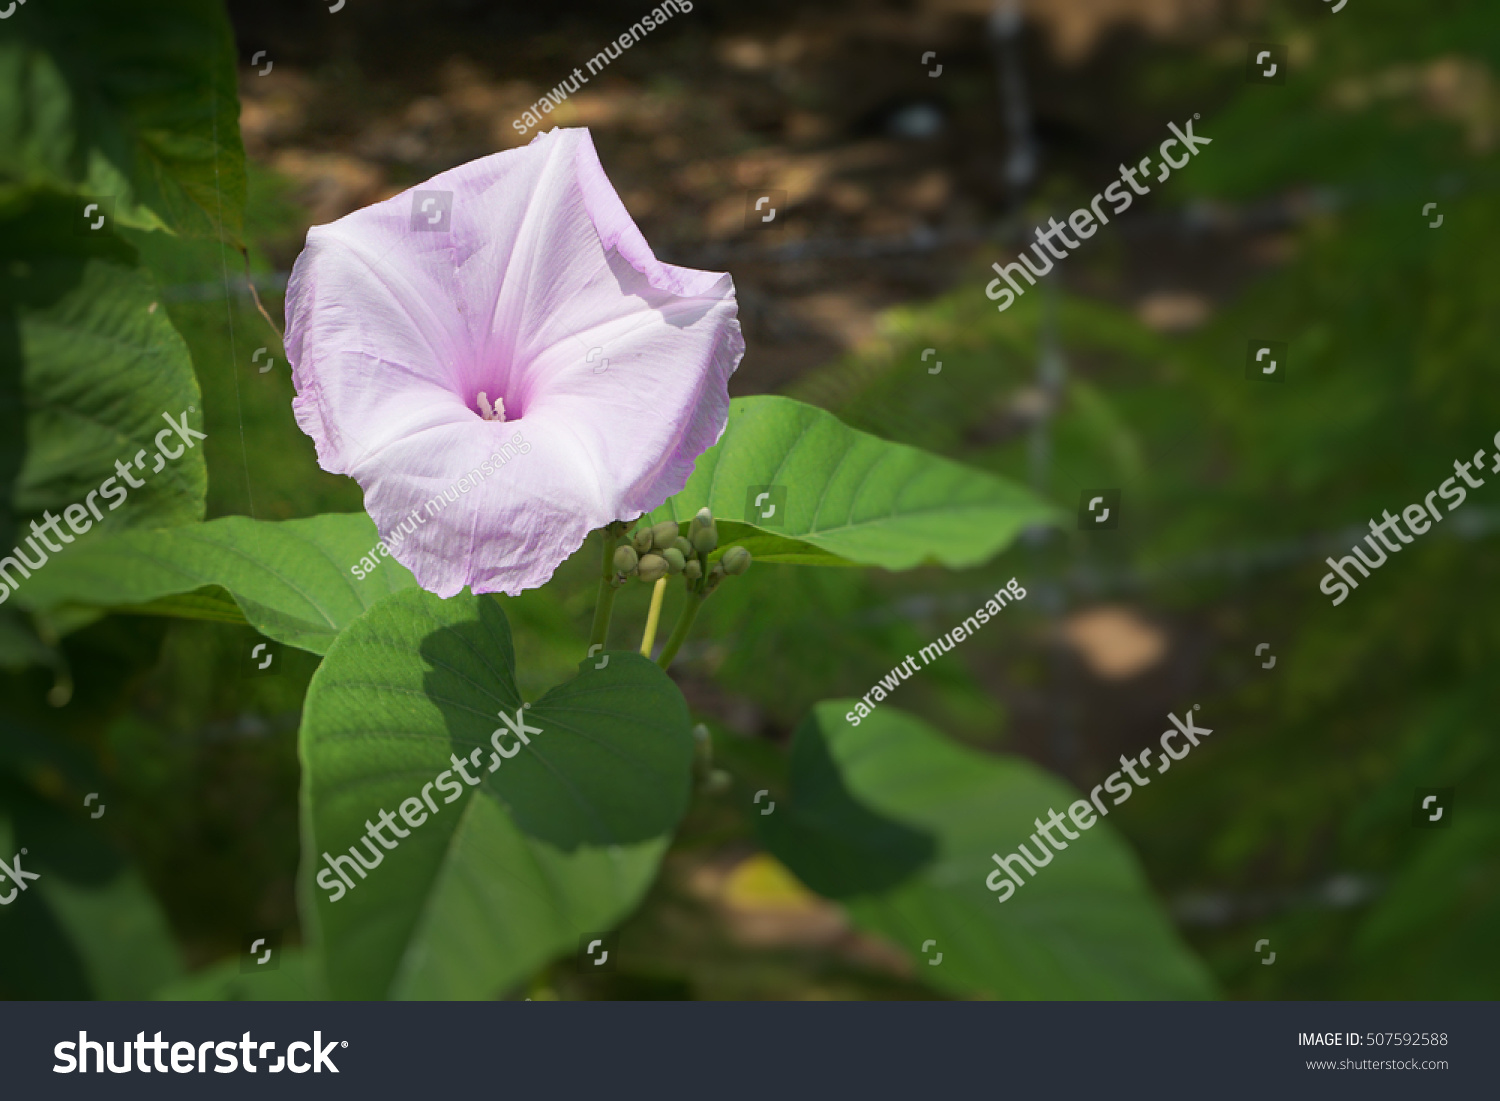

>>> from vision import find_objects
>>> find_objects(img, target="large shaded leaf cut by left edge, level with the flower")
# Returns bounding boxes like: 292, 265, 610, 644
0, 194, 207, 561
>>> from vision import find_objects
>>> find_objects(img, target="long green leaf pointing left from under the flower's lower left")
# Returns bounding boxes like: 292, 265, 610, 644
17, 513, 417, 654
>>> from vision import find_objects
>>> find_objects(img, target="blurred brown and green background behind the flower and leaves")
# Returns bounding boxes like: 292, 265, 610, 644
0, 0, 1500, 999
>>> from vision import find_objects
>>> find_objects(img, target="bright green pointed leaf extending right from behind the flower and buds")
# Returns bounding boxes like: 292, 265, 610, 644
650, 396, 1058, 570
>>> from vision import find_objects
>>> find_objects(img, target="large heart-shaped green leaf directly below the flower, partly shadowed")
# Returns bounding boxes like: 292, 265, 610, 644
302, 590, 693, 998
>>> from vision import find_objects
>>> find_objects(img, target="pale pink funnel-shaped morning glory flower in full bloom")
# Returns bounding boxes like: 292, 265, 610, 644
287, 129, 744, 597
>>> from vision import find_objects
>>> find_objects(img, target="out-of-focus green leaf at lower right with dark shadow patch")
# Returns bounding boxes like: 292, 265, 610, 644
758, 701, 1214, 999
